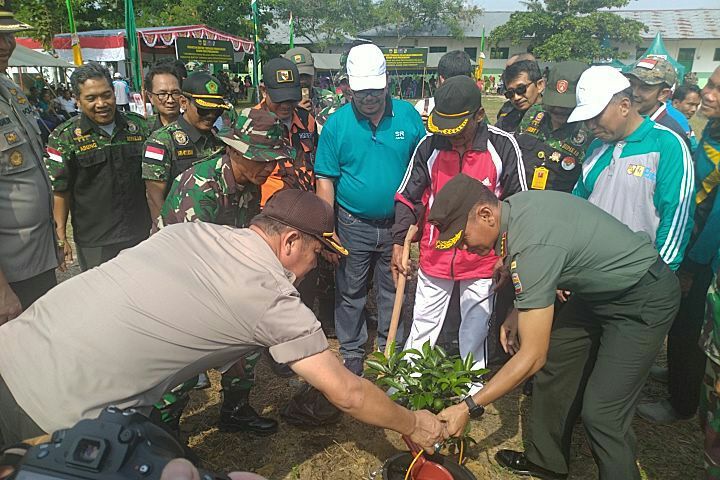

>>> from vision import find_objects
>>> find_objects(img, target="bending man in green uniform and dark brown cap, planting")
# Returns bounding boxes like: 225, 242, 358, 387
428, 174, 680, 480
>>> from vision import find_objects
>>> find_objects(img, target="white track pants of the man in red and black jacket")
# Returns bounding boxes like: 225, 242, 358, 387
405, 270, 494, 368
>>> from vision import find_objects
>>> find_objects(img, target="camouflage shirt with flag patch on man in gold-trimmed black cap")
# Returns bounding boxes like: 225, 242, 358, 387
142, 116, 223, 190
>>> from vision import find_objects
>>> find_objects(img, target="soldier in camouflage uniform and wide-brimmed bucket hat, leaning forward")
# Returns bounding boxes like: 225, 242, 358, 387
156, 108, 294, 435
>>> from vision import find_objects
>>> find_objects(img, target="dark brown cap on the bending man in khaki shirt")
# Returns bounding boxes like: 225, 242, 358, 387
262, 188, 348, 256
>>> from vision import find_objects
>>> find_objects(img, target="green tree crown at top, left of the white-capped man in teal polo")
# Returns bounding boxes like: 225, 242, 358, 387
273, 0, 375, 50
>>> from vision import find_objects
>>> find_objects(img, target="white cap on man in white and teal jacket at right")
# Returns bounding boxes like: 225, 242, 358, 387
568, 65, 630, 123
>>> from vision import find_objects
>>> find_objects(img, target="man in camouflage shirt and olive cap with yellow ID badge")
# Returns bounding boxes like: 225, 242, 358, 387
515, 61, 592, 193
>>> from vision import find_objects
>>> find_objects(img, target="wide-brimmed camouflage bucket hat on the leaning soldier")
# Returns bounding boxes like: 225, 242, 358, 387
215, 108, 294, 162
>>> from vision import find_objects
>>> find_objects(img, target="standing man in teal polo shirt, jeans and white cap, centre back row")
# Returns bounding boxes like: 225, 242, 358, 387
315, 44, 425, 375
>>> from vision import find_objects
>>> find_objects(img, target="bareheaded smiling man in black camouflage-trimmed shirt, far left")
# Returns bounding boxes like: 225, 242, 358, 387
46, 62, 150, 270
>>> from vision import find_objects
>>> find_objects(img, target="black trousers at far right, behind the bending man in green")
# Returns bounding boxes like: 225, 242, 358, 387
667, 266, 712, 417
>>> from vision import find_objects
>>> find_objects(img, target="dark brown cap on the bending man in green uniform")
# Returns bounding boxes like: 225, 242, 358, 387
428, 173, 487, 250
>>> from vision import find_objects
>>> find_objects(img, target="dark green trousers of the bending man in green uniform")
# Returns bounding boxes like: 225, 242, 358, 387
526, 261, 680, 480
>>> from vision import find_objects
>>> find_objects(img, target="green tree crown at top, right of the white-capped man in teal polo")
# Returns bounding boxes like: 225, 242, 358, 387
377, 0, 480, 47
